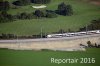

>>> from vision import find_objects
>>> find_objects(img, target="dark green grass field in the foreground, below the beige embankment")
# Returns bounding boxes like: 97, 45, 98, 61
0, 48, 100, 66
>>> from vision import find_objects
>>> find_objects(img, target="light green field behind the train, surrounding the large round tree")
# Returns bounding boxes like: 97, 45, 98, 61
0, 0, 100, 35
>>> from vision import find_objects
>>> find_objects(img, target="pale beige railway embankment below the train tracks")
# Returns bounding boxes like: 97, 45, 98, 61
0, 34, 100, 51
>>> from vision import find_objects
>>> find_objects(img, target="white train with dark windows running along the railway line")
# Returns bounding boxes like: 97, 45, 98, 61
47, 30, 100, 38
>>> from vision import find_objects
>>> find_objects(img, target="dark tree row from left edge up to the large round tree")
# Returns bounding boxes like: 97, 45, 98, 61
0, 10, 57, 23
